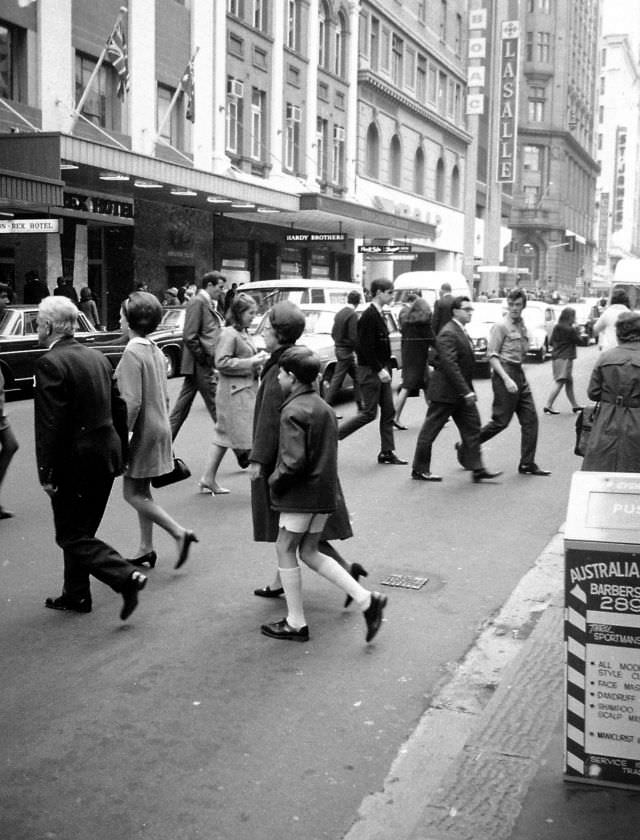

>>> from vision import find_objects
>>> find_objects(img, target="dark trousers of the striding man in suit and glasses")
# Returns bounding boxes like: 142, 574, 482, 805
412, 400, 482, 473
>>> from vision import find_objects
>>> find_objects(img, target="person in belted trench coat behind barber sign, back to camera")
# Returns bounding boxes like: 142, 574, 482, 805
582, 312, 640, 472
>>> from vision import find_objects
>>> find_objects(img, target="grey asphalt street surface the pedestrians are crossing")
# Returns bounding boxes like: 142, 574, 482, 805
0, 348, 597, 840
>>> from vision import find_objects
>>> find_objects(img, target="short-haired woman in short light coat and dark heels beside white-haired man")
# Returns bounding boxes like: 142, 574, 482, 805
116, 292, 198, 569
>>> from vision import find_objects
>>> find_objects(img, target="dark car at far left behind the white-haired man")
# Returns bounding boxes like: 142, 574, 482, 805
0, 304, 123, 390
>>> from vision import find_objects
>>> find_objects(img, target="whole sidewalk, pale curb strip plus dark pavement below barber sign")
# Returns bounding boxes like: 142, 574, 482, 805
346, 533, 640, 840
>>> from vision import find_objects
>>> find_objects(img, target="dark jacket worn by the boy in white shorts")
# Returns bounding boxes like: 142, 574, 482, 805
269, 385, 338, 513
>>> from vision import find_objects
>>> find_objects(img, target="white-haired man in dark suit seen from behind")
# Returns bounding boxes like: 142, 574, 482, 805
34, 296, 147, 621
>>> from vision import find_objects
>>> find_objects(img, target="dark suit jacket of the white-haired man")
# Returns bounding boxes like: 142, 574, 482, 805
34, 337, 127, 486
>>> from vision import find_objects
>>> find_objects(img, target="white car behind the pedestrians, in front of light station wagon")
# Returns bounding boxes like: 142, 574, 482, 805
255, 304, 402, 395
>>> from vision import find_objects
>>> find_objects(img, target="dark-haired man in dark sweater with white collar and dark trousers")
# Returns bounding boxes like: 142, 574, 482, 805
338, 280, 407, 464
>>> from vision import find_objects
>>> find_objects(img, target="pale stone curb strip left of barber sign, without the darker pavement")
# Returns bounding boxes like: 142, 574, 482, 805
344, 531, 564, 840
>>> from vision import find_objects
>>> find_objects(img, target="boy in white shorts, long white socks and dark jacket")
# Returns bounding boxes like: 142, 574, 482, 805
261, 346, 387, 642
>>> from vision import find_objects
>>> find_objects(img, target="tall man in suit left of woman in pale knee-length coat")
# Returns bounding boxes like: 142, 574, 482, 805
169, 271, 225, 440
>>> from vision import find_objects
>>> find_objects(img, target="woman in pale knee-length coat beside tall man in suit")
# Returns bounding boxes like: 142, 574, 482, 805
198, 294, 268, 495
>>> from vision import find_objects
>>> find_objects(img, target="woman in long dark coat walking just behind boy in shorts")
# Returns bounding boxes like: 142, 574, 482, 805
249, 300, 367, 606
